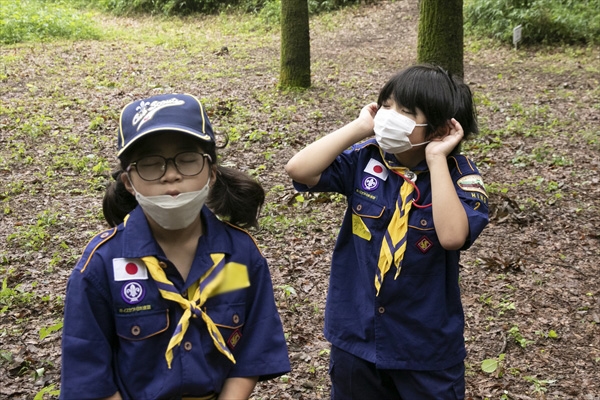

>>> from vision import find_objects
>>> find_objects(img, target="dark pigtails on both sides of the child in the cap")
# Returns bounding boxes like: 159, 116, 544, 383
102, 135, 265, 228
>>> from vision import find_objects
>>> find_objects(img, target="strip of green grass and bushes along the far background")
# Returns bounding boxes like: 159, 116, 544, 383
0, 0, 600, 45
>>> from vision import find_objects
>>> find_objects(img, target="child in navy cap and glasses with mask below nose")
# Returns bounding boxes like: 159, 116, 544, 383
60, 94, 290, 400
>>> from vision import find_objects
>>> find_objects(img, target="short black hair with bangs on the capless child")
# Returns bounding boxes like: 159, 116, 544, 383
377, 64, 478, 153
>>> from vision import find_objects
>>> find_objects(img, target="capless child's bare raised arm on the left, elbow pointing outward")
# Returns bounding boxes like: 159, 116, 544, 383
285, 103, 377, 186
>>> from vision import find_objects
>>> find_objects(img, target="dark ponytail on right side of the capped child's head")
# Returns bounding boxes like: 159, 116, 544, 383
206, 166, 265, 228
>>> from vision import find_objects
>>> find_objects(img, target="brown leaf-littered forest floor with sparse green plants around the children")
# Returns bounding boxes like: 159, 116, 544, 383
0, 0, 600, 400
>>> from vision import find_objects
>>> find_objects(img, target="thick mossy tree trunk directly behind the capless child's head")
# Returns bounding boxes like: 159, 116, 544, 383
417, 0, 464, 77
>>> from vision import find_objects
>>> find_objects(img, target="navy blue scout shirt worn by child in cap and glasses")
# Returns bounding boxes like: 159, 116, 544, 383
60, 207, 290, 400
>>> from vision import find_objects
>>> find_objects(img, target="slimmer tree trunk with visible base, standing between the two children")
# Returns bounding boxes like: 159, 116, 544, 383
279, 0, 310, 88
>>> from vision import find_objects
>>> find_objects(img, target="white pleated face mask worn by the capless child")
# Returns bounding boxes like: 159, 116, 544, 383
374, 108, 429, 154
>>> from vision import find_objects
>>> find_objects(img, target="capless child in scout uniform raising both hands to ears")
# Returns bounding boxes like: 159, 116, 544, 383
286, 65, 488, 400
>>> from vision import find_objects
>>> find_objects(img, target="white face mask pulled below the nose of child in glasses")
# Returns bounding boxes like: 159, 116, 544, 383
130, 180, 210, 230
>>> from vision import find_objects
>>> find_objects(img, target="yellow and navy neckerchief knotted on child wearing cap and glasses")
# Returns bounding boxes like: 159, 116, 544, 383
142, 253, 250, 369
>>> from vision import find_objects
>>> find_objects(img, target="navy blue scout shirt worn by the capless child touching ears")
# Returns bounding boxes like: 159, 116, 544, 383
294, 140, 488, 370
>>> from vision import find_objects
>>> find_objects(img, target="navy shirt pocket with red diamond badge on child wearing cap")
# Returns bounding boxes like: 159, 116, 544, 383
204, 303, 246, 351
